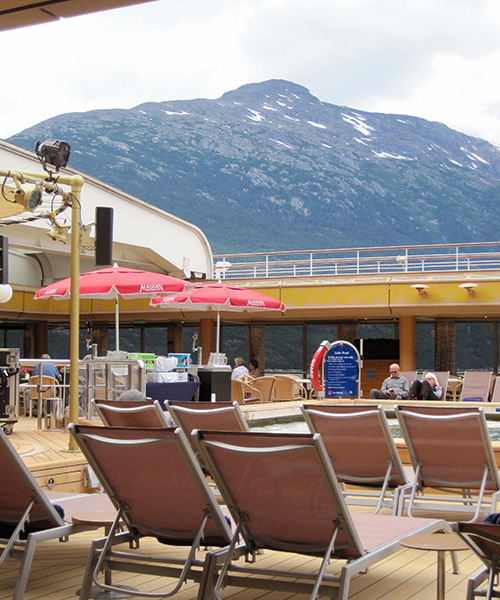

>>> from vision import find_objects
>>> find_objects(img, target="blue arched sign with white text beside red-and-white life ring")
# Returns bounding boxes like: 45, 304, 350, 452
324, 342, 360, 398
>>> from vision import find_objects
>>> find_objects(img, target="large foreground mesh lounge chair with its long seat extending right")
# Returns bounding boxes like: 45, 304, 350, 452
196, 431, 458, 600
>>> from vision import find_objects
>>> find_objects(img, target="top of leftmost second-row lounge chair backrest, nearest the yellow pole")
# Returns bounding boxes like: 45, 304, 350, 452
91, 400, 171, 427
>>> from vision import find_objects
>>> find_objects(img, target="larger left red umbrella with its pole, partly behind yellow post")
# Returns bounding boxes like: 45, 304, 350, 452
35, 264, 190, 350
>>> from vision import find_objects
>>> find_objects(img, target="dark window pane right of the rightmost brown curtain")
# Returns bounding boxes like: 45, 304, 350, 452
455, 322, 493, 371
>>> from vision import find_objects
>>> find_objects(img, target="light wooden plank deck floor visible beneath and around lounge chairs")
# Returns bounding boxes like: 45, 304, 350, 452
0, 420, 488, 600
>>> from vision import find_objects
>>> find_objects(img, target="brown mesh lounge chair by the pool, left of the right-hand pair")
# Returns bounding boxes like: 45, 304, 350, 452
301, 405, 413, 515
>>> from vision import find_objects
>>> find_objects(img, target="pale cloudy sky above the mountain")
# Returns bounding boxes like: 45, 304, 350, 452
0, 0, 500, 144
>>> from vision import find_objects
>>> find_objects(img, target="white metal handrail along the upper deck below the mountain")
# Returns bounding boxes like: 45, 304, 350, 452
214, 242, 500, 279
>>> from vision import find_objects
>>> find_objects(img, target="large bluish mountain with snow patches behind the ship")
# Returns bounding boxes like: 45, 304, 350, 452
8, 80, 500, 253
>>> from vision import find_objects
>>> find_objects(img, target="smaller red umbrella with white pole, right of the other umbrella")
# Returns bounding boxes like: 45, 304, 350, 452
150, 283, 286, 352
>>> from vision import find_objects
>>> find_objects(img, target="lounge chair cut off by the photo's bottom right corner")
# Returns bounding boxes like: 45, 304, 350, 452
457, 523, 500, 600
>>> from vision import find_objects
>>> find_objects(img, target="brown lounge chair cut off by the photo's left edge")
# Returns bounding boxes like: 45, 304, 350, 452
0, 430, 113, 600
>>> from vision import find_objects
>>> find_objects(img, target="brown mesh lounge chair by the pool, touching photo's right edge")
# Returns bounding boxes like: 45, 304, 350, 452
395, 406, 500, 521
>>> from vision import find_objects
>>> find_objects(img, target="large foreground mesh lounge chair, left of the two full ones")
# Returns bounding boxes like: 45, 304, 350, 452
70, 424, 231, 600
